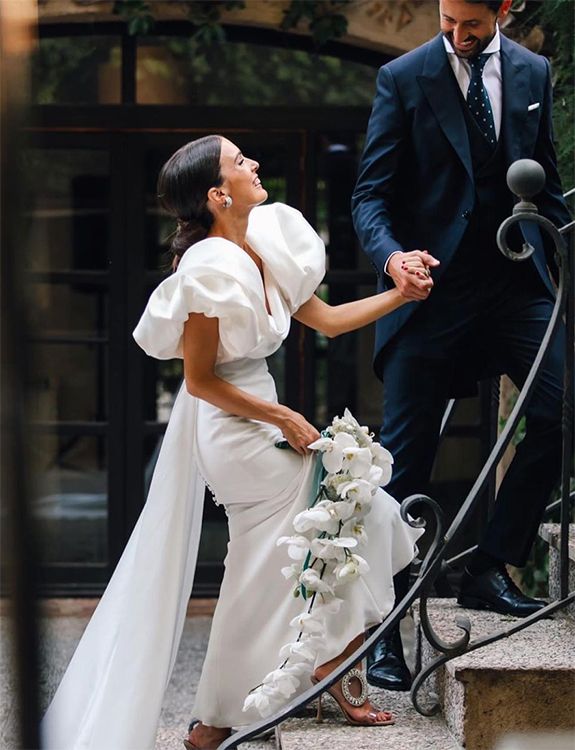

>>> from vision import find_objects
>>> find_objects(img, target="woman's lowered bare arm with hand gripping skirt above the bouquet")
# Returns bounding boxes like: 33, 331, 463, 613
183, 313, 319, 454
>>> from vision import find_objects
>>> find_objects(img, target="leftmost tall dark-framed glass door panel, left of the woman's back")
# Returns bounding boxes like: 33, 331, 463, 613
24, 147, 114, 584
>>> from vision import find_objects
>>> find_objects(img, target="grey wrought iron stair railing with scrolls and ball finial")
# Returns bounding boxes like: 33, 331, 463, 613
218, 159, 575, 750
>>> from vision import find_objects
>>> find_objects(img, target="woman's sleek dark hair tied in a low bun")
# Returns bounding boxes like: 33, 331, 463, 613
157, 135, 223, 270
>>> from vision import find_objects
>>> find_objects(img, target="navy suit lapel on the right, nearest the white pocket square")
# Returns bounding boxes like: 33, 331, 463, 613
501, 36, 529, 164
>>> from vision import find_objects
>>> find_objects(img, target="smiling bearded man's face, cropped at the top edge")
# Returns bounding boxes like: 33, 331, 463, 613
439, 0, 511, 57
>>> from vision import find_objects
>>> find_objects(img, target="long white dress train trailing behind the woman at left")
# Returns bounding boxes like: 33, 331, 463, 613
41, 385, 205, 750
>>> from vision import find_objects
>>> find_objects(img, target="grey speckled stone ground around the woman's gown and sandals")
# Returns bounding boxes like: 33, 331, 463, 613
0, 615, 458, 750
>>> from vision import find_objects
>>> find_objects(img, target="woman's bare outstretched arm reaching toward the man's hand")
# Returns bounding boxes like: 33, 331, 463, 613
293, 280, 416, 338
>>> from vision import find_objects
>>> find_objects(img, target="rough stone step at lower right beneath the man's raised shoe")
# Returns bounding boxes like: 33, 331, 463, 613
414, 599, 575, 750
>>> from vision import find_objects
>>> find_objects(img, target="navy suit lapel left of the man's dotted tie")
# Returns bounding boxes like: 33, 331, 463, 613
418, 34, 473, 180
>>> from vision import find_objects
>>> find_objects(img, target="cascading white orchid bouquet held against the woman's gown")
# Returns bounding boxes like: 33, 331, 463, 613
244, 409, 393, 717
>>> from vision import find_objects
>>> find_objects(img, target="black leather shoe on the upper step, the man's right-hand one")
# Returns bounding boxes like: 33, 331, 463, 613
457, 565, 547, 617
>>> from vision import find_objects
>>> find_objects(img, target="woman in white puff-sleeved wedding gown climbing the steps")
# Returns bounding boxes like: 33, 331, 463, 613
42, 136, 433, 750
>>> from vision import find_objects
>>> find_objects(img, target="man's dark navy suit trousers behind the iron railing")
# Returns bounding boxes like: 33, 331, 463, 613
381, 254, 565, 566
